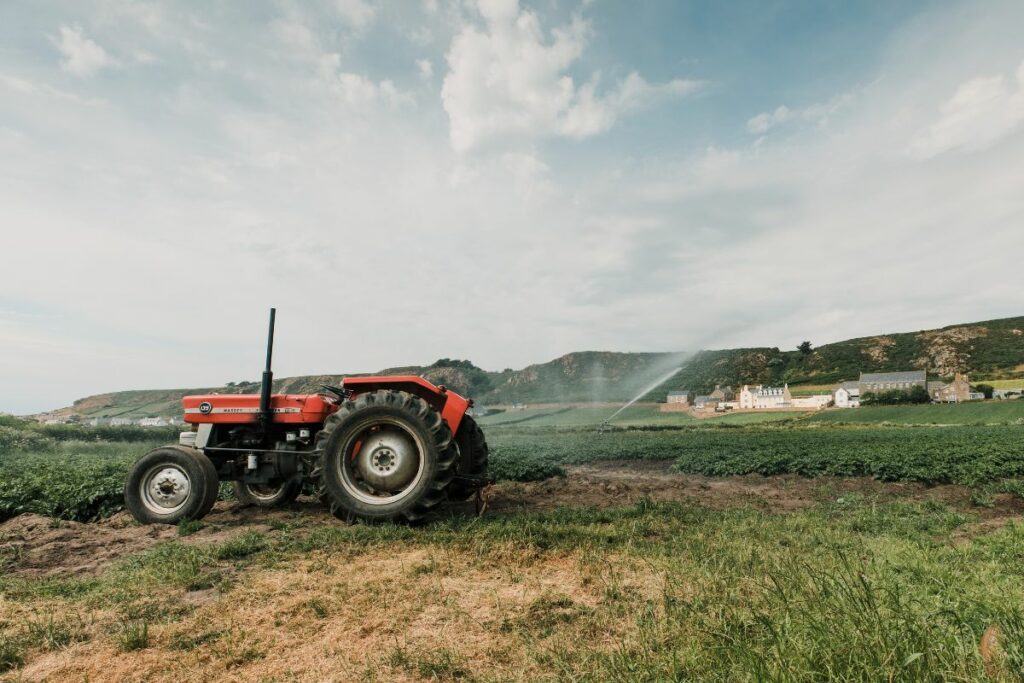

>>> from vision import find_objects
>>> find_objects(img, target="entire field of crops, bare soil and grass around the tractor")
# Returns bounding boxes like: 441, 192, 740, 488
0, 401, 1024, 682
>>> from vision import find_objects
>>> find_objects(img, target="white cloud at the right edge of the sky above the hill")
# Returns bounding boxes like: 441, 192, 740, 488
909, 61, 1024, 159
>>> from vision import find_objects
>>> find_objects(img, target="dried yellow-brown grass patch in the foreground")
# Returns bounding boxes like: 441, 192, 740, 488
4, 543, 659, 683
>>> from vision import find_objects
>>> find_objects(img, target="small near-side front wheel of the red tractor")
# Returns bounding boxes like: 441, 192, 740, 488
125, 445, 218, 524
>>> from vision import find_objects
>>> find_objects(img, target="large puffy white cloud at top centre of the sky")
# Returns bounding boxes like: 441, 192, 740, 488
441, 0, 699, 152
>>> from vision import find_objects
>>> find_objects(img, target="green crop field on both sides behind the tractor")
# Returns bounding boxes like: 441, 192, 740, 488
6, 401, 1024, 535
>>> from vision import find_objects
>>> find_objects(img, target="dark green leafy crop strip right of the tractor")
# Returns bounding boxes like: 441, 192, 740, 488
488, 423, 1024, 485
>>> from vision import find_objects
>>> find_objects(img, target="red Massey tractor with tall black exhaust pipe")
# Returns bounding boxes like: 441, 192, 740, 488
125, 308, 487, 524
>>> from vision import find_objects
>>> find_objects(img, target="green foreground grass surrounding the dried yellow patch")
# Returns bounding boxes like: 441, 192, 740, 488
0, 500, 1024, 681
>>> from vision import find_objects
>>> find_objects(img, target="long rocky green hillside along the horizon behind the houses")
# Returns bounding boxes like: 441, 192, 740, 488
46, 316, 1024, 418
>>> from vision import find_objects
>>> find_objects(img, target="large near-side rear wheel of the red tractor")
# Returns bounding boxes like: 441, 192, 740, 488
312, 390, 455, 522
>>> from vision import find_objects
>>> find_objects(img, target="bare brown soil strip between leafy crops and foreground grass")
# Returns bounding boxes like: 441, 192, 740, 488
0, 462, 1024, 578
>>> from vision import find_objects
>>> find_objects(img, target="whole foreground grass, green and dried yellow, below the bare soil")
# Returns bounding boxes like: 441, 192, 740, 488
0, 499, 1024, 681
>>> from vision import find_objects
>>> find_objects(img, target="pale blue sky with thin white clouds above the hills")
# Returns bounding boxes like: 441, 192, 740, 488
0, 0, 1024, 414
